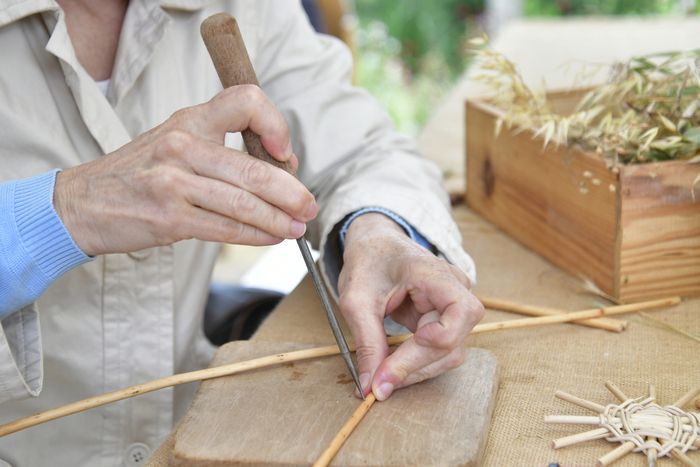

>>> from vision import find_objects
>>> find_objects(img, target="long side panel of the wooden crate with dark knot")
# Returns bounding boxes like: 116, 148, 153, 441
466, 101, 619, 295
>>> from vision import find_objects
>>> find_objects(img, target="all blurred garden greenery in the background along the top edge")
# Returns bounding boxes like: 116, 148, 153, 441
355, 0, 700, 134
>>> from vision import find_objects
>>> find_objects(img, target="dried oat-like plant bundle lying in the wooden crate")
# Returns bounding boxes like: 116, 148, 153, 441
472, 38, 700, 166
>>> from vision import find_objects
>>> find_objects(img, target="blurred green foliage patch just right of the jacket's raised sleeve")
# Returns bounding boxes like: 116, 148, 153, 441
356, 0, 483, 134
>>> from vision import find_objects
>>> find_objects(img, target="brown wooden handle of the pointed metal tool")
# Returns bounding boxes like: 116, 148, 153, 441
200, 13, 294, 174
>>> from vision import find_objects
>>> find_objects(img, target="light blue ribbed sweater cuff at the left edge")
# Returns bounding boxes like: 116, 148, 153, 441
0, 170, 92, 319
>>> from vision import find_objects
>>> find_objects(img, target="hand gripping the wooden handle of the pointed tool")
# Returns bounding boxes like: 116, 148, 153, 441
54, 86, 318, 256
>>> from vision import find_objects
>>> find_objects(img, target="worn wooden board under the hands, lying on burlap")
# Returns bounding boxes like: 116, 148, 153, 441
173, 341, 498, 467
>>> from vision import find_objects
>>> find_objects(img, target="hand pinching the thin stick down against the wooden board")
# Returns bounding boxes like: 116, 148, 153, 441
338, 213, 484, 400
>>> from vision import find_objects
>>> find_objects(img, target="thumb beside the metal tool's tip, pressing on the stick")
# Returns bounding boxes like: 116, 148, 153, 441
340, 295, 389, 395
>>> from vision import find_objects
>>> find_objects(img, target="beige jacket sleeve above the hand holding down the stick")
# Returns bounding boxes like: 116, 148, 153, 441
255, 2, 475, 294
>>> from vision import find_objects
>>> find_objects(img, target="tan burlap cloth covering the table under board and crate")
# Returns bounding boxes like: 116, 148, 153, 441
148, 207, 700, 467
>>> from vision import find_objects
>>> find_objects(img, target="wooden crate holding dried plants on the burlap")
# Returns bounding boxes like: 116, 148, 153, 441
466, 92, 700, 302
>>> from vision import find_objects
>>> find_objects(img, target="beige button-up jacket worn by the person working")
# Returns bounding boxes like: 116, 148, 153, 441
0, 0, 474, 467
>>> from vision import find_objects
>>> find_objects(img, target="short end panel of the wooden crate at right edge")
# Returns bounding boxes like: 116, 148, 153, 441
619, 161, 700, 301
